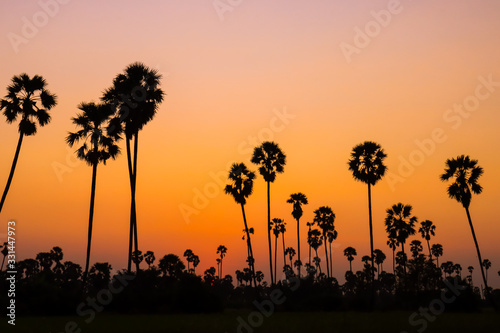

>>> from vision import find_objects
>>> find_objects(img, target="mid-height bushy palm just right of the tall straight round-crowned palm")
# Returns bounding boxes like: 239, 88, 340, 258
385, 203, 417, 272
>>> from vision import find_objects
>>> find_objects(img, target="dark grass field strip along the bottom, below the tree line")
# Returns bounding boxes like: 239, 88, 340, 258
0, 311, 500, 333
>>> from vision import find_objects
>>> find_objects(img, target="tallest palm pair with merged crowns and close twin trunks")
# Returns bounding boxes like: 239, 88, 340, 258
102, 62, 164, 272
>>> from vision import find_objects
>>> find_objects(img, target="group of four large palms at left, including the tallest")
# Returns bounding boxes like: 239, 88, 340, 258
0, 63, 164, 286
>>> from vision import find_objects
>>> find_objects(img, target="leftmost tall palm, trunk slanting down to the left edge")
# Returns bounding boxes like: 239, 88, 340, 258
0, 73, 57, 212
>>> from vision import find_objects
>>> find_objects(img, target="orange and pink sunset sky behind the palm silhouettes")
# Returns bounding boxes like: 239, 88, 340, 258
0, 0, 500, 287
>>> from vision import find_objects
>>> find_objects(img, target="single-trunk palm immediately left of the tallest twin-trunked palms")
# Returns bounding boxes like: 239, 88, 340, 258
66, 103, 120, 285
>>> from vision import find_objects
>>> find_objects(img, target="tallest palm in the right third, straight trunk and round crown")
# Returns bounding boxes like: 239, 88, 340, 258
348, 141, 387, 279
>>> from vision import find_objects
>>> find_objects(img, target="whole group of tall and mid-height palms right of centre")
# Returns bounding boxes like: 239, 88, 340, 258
225, 141, 488, 296
